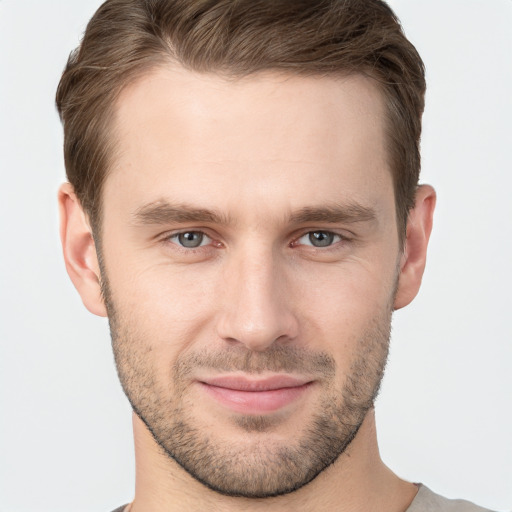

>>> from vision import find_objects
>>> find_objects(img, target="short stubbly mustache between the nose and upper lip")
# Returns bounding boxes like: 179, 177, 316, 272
174, 345, 336, 379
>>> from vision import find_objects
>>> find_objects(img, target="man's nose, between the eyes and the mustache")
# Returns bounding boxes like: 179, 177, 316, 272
217, 245, 298, 352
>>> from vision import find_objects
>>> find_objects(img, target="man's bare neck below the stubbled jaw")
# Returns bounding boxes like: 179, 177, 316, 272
130, 410, 417, 512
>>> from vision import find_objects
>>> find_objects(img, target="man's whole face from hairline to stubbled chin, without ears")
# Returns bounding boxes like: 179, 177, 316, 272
101, 69, 400, 497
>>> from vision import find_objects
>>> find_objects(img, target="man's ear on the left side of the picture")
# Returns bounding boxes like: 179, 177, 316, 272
59, 183, 107, 316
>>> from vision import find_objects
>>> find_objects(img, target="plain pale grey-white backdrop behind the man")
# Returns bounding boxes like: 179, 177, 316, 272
0, 0, 512, 512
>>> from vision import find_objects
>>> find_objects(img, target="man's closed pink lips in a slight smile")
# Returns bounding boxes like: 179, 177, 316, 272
197, 375, 313, 415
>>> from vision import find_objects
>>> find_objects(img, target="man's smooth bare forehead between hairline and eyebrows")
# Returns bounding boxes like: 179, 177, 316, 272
105, 66, 391, 216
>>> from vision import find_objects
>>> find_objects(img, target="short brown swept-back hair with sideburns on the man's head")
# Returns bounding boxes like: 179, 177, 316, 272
56, 0, 425, 240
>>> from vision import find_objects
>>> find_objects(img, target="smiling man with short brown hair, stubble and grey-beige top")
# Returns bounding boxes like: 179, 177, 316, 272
57, 0, 496, 512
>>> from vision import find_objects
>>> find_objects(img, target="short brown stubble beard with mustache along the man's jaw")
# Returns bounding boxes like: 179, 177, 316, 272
102, 279, 391, 498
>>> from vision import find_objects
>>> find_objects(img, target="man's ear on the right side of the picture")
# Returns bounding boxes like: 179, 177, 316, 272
394, 185, 436, 309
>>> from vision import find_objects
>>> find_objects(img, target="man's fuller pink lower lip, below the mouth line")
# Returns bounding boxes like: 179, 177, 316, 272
200, 382, 311, 414
